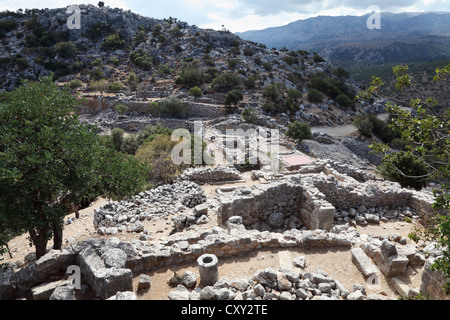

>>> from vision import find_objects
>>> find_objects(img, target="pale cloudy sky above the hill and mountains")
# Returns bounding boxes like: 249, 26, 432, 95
0, 0, 450, 32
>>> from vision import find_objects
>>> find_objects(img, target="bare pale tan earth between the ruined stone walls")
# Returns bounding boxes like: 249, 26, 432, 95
3, 175, 422, 300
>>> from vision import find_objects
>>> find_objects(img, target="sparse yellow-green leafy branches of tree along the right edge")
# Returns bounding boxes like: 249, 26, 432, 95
358, 65, 450, 294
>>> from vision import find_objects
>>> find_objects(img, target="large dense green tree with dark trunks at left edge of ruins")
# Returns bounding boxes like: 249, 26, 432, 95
0, 77, 146, 258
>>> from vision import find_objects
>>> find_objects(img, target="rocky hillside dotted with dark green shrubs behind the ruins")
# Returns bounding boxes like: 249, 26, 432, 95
0, 5, 380, 129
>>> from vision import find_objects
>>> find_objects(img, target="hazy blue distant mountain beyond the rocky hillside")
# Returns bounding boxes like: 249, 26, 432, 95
238, 12, 450, 63
